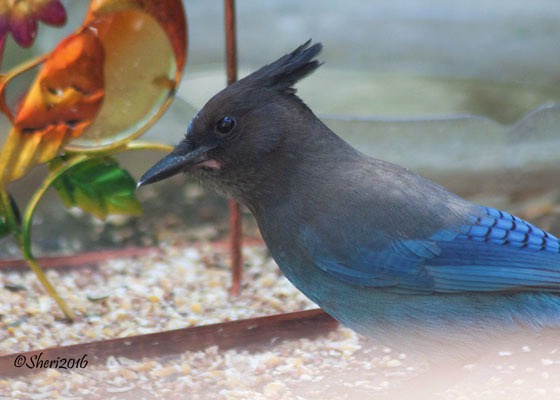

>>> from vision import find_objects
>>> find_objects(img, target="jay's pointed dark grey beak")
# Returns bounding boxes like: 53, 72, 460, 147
136, 142, 215, 188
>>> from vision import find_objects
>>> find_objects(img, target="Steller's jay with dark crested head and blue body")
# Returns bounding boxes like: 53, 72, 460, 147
139, 42, 560, 354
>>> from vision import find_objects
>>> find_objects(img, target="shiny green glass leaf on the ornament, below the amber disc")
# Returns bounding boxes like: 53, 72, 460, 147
51, 156, 142, 219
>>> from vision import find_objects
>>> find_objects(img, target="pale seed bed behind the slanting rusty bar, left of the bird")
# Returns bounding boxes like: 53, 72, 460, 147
0, 245, 316, 354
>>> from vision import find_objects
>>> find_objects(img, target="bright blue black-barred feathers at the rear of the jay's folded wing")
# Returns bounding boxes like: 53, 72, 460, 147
423, 207, 560, 292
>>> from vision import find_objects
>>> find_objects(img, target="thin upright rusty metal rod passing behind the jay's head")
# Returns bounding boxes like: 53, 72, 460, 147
224, 0, 243, 296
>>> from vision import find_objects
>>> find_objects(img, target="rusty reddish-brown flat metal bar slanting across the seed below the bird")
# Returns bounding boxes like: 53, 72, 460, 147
0, 309, 338, 379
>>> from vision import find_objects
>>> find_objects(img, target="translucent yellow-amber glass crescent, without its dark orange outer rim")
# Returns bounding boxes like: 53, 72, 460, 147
65, 10, 177, 151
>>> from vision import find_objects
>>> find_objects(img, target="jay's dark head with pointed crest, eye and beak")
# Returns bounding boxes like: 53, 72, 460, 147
138, 41, 322, 200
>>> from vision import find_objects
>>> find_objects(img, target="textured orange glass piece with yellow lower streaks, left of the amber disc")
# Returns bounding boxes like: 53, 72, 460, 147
0, 28, 105, 187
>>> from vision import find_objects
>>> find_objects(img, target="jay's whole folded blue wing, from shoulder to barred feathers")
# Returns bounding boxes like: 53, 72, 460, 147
308, 207, 560, 293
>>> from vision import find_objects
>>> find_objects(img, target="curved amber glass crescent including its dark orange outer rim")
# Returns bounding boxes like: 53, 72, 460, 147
66, 0, 187, 151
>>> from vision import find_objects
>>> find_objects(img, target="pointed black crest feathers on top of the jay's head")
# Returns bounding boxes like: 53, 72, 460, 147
243, 40, 323, 93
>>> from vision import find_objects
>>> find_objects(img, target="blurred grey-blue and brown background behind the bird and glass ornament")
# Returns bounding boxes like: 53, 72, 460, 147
0, 0, 560, 258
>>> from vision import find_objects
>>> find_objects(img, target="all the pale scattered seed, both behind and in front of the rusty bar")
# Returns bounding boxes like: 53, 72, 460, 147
0, 245, 560, 400
